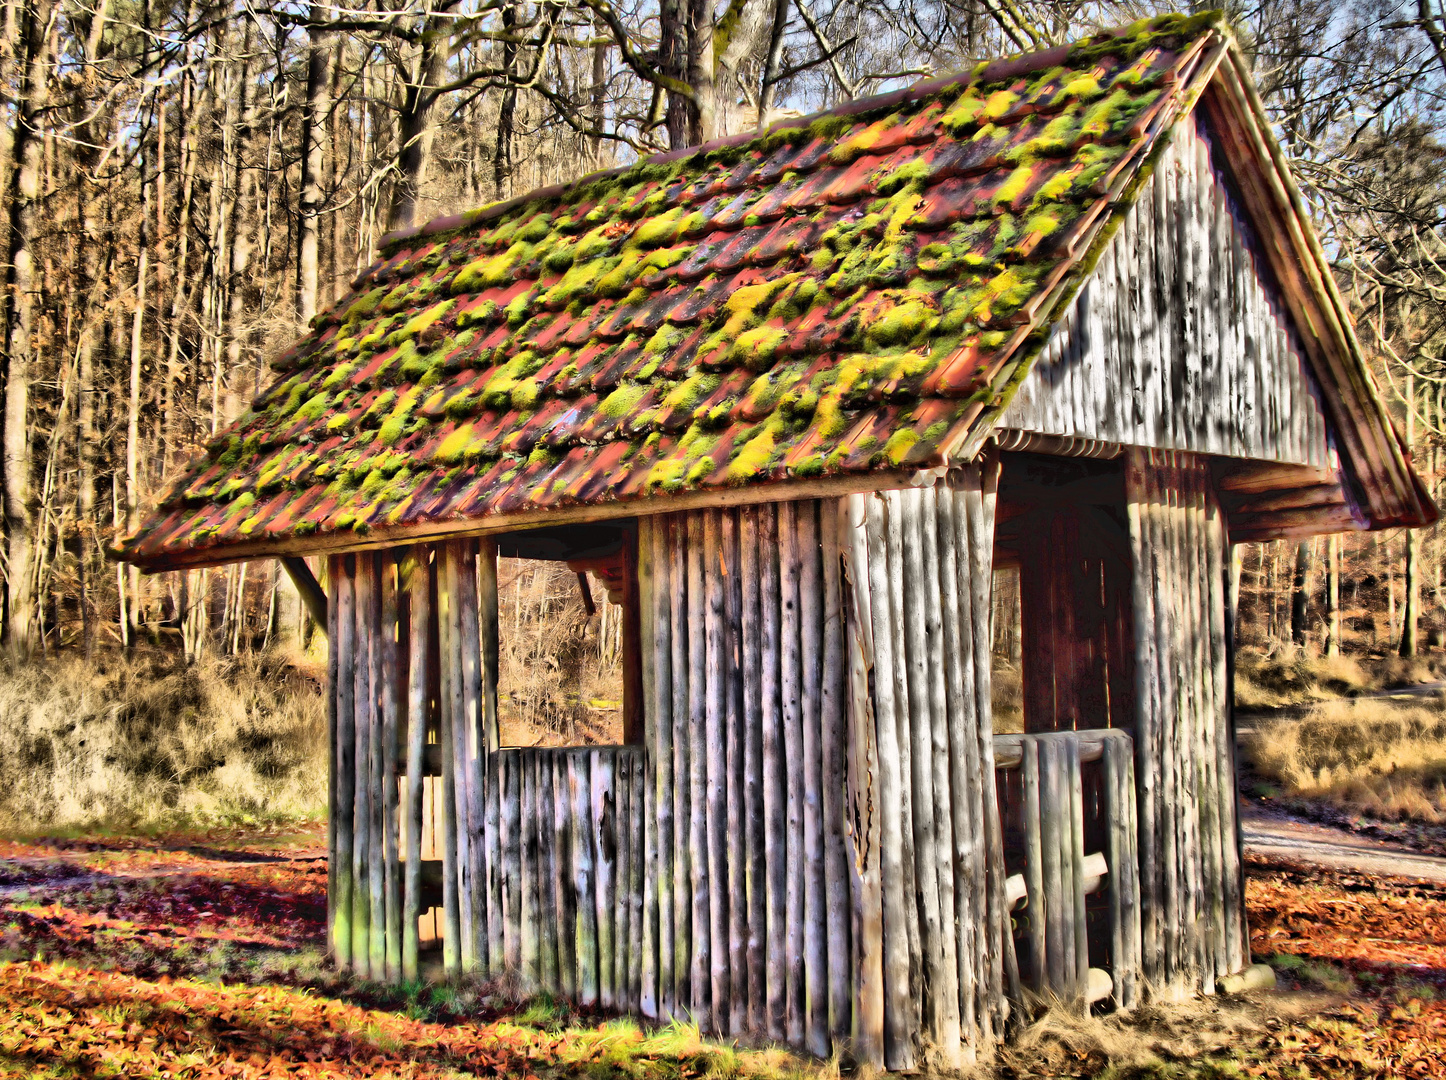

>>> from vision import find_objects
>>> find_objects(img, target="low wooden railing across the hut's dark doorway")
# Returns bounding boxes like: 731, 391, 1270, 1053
995, 729, 1141, 1009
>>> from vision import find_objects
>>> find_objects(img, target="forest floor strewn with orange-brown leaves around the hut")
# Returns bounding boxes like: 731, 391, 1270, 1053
0, 826, 1446, 1080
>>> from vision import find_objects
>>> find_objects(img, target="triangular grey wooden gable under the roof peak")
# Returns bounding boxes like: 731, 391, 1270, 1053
999, 119, 1335, 467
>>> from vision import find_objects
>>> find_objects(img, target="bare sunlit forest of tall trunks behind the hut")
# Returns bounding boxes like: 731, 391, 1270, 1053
0, 0, 1446, 832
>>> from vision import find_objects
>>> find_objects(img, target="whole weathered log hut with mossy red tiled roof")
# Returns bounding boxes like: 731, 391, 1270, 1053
119, 16, 1436, 1068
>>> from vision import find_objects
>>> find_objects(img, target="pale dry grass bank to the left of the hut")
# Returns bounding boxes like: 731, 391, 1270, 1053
0, 653, 327, 834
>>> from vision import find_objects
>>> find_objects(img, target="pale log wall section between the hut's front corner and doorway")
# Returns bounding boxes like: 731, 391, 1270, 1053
840, 466, 1018, 1068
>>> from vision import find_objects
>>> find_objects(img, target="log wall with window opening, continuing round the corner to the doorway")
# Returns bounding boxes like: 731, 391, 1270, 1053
321, 468, 1017, 1067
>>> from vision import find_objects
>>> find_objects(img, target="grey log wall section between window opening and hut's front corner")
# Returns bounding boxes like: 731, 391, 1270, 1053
638, 500, 853, 1054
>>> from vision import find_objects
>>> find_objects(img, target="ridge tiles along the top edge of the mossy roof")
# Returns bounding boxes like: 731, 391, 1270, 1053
367, 9, 1233, 270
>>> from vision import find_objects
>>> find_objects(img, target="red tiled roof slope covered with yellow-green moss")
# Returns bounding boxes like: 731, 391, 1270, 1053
120, 16, 1226, 565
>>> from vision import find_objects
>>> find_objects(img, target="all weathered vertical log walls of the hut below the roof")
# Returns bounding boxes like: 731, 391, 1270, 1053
328, 451, 1245, 1068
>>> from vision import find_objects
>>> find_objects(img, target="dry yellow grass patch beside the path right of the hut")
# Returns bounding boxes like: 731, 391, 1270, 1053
1245, 698, 1446, 824
